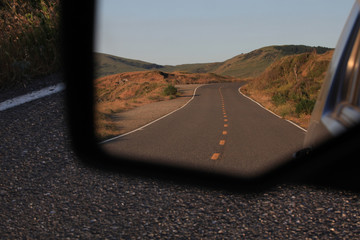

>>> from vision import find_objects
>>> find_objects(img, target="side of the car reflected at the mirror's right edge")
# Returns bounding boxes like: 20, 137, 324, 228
304, 1, 360, 147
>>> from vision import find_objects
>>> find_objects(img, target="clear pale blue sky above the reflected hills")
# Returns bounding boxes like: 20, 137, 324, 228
94, 0, 354, 65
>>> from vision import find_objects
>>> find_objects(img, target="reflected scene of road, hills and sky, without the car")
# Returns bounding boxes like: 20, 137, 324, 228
94, 0, 352, 177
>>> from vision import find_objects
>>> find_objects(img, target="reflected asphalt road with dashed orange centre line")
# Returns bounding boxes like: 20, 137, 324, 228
102, 83, 305, 177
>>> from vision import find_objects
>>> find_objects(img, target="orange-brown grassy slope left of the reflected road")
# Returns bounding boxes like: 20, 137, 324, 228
95, 70, 237, 139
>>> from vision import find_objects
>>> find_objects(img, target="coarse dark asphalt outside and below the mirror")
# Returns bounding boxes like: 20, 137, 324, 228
0, 80, 360, 239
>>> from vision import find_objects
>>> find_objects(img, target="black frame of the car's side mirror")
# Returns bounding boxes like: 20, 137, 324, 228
61, 0, 360, 191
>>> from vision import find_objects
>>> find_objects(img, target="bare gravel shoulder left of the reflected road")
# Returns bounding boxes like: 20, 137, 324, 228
108, 84, 203, 137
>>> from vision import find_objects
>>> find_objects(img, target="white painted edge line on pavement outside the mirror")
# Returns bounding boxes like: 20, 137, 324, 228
0, 83, 65, 111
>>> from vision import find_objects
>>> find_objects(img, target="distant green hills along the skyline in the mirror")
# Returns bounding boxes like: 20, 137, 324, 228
95, 45, 331, 78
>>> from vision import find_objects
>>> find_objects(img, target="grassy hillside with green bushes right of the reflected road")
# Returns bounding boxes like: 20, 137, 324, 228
243, 50, 333, 128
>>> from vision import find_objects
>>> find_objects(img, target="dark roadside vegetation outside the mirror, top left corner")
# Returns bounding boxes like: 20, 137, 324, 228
0, 0, 60, 90
